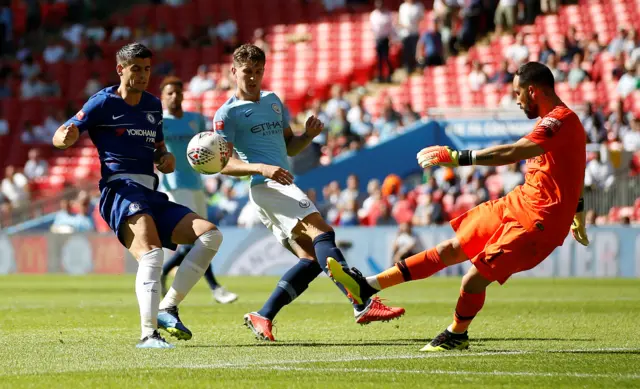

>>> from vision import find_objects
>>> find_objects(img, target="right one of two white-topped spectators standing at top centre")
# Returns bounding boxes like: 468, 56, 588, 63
398, 0, 424, 74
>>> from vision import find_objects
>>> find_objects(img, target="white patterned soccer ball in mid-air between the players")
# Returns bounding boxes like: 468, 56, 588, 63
187, 131, 231, 174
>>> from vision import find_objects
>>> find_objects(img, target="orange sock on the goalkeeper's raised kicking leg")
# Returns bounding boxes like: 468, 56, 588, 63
376, 247, 446, 289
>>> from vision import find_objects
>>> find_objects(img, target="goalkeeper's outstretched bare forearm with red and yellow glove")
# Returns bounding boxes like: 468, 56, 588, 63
417, 138, 545, 168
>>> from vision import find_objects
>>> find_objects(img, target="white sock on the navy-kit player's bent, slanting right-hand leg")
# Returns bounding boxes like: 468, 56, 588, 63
160, 230, 222, 309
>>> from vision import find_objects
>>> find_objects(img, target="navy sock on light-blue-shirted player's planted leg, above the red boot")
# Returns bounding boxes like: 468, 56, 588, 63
258, 258, 322, 320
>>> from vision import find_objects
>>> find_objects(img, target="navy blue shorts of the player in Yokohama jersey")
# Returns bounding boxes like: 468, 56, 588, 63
100, 179, 192, 250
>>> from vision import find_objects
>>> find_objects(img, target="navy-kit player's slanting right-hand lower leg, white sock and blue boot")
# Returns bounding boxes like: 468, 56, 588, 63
158, 229, 222, 340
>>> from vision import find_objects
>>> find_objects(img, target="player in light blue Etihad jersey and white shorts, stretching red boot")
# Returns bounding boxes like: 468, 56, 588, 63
214, 45, 404, 341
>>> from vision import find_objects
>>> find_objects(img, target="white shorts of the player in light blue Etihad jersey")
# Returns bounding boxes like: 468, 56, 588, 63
249, 181, 318, 242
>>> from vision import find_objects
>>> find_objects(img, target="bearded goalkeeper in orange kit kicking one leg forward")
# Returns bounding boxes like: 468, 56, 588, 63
328, 62, 589, 351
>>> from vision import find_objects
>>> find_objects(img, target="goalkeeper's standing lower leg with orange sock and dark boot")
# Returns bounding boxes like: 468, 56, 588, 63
420, 267, 491, 352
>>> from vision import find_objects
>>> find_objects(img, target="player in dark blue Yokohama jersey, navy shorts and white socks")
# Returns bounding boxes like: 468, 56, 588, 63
53, 43, 222, 348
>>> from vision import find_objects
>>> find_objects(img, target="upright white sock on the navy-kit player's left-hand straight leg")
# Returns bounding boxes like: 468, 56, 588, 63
136, 249, 164, 339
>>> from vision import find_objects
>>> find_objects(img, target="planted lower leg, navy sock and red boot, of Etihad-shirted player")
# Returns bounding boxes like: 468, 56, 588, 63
244, 258, 322, 341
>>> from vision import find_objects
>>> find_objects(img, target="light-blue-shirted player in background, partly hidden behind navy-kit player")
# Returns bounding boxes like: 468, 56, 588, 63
160, 76, 238, 304
